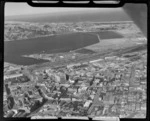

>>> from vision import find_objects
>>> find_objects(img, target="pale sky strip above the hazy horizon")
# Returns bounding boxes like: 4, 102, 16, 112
5, 2, 122, 16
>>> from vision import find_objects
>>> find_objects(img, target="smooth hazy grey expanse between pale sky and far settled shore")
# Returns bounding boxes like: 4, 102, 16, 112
5, 10, 131, 22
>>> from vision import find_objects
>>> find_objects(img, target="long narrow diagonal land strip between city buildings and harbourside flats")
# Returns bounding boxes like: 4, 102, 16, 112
28, 44, 147, 72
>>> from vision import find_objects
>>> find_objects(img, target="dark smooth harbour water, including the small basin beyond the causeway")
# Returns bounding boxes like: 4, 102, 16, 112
4, 31, 121, 65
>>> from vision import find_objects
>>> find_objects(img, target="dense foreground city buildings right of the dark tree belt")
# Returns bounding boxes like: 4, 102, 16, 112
3, 50, 147, 118
